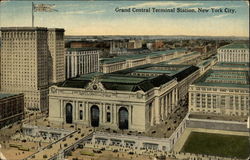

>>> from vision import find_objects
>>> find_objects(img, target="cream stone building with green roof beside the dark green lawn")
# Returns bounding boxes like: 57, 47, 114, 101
189, 66, 249, 116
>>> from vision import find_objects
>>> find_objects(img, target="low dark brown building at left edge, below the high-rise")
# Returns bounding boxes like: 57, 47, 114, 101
0, 93, 24, 128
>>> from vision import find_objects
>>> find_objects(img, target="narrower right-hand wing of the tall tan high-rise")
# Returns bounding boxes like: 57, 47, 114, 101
48, 28, 65, 83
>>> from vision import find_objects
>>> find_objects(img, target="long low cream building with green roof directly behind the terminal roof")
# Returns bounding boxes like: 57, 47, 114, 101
100, 49, 193, 73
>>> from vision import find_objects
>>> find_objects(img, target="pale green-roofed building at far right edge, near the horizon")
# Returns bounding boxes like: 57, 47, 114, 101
217, 43, 250, 62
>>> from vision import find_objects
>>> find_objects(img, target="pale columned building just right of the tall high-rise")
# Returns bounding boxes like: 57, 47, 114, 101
66, 48, 100, 79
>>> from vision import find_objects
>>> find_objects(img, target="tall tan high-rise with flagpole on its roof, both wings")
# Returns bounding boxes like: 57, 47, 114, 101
1, 27, 64, 111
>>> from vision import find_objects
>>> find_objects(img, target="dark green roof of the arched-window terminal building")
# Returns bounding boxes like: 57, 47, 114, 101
58, 64, 199, 92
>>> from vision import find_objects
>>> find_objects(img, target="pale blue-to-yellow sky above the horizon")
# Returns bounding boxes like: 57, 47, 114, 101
0, 0, 249, 37
